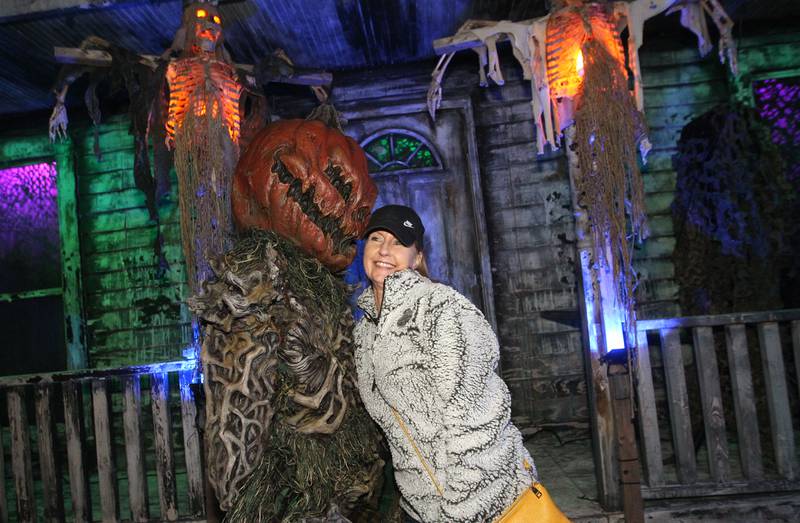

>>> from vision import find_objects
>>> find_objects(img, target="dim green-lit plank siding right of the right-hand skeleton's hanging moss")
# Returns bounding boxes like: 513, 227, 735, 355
634, 33, 800, 318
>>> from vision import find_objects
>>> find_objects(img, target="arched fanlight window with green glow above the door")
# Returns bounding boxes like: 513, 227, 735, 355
361, 129, 443, 174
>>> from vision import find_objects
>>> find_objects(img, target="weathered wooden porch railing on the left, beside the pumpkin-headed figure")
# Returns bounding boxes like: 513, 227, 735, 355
0, 361, 204, 522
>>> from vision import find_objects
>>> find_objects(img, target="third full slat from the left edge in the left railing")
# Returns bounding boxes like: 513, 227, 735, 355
62, 381, 92, 523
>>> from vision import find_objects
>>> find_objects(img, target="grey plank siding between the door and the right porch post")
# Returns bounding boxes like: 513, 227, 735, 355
473, 64, 589, 432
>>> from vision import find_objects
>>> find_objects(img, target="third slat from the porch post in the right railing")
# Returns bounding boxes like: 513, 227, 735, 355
692, 327, 730, 482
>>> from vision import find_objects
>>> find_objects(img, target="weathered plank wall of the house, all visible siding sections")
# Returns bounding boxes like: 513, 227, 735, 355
1, 27, 800, 429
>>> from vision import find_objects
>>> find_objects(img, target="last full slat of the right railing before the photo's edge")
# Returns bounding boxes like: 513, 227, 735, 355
758, 322, 795, 479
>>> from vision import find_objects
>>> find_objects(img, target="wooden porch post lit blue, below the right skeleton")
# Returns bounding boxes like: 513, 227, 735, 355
564, 125, 622, 510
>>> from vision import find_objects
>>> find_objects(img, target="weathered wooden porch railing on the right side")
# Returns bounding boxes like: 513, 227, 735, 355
637, 309, 800, 499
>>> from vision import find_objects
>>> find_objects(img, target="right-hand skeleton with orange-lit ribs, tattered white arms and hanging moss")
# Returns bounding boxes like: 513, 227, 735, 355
428, 0, 736, 339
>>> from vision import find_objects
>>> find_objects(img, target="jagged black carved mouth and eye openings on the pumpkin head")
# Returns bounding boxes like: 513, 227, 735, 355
271, 153, 369, 254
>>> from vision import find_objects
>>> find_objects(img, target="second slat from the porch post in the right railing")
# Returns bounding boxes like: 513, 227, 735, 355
660, 329, 697, 485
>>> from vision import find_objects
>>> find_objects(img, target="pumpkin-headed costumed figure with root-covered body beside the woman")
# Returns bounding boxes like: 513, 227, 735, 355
190, 105, 383, 522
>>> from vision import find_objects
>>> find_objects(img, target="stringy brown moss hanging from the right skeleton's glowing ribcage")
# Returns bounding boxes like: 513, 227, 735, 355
575, 38, 647, 332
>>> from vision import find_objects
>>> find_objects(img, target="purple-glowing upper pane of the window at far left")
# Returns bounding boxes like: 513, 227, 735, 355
0, 162, 61, 292
